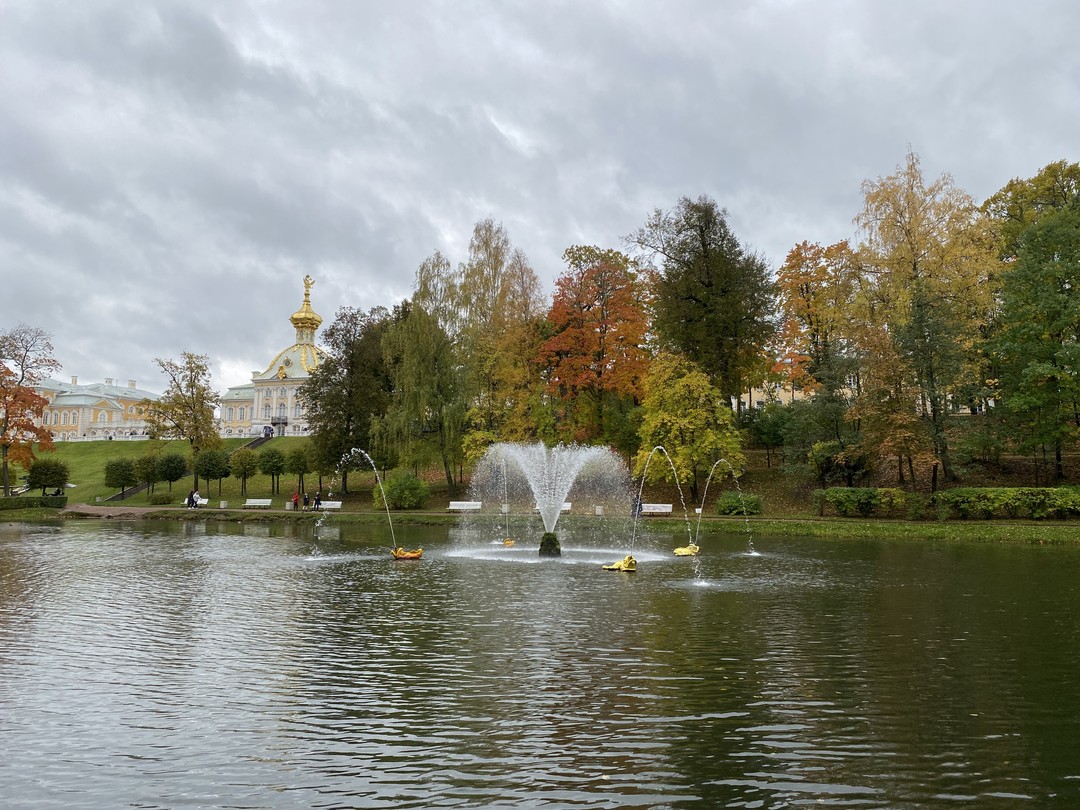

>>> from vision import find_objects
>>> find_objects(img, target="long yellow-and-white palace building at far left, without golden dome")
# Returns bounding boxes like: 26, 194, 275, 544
35, 377, 158, 442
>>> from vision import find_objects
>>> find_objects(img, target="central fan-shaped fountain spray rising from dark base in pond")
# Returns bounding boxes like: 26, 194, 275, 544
470, 442, 630, 557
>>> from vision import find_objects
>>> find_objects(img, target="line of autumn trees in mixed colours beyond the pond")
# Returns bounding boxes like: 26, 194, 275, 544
0, 152, 1080, 498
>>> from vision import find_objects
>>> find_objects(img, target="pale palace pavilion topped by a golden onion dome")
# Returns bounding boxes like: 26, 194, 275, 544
218, 275, 323, 438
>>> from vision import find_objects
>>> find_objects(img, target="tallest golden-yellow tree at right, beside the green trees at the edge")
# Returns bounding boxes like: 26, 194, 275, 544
855, 152, 998, 481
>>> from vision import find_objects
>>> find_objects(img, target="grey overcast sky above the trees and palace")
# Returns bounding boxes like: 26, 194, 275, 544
0, 0, 1080, 391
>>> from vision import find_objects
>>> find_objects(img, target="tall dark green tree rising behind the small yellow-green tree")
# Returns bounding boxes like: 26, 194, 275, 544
627, 197, 775, 408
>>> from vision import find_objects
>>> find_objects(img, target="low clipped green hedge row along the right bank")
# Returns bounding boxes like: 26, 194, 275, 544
813, 487, 1080, 521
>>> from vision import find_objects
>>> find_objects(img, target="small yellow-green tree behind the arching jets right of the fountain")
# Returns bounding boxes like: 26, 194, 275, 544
634, 354, 745, 502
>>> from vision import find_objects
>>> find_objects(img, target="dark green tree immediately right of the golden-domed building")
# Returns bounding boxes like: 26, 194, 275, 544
300, 307, 391, 486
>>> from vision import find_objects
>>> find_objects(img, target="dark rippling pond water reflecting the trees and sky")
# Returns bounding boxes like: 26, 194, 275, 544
0, 523, 1080, 808
